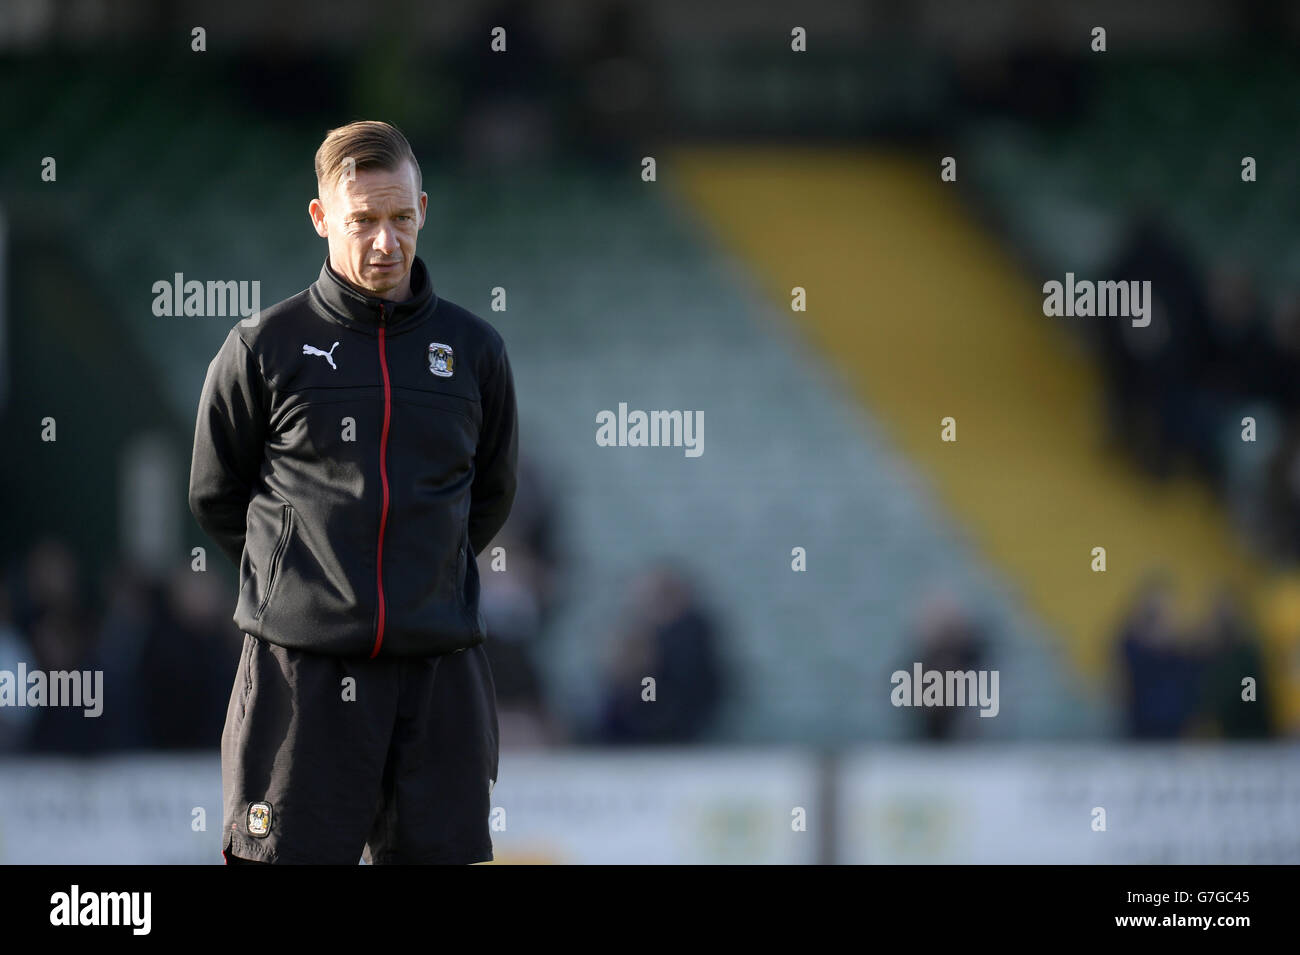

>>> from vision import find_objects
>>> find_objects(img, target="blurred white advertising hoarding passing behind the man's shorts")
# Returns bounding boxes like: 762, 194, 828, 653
0, 750, 819, 864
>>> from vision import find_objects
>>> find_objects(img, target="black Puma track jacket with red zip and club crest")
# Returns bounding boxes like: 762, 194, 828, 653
190, 257, 519, 657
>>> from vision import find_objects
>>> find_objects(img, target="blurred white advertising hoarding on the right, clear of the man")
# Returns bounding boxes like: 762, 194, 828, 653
836, 743, 1300, 864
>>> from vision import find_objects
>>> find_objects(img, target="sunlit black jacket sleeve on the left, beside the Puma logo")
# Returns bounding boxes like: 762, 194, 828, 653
190, 326, 269, 567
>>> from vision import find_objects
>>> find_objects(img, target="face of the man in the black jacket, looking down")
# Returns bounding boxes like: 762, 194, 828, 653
307, 162, 429, 301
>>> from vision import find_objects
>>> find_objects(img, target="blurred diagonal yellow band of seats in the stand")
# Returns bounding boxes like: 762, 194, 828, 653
676, 147, 1300, 717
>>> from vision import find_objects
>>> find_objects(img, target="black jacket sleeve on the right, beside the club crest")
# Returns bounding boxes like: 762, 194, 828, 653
469, 346, 519, 556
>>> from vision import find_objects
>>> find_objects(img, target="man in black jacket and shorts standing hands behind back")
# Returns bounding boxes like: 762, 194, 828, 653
190, 122, 517, 864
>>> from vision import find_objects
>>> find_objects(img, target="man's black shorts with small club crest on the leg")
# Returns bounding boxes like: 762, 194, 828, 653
221, 634, 498, 865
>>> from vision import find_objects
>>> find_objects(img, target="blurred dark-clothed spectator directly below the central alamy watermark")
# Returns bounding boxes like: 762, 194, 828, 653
595, 565, 725, 743
